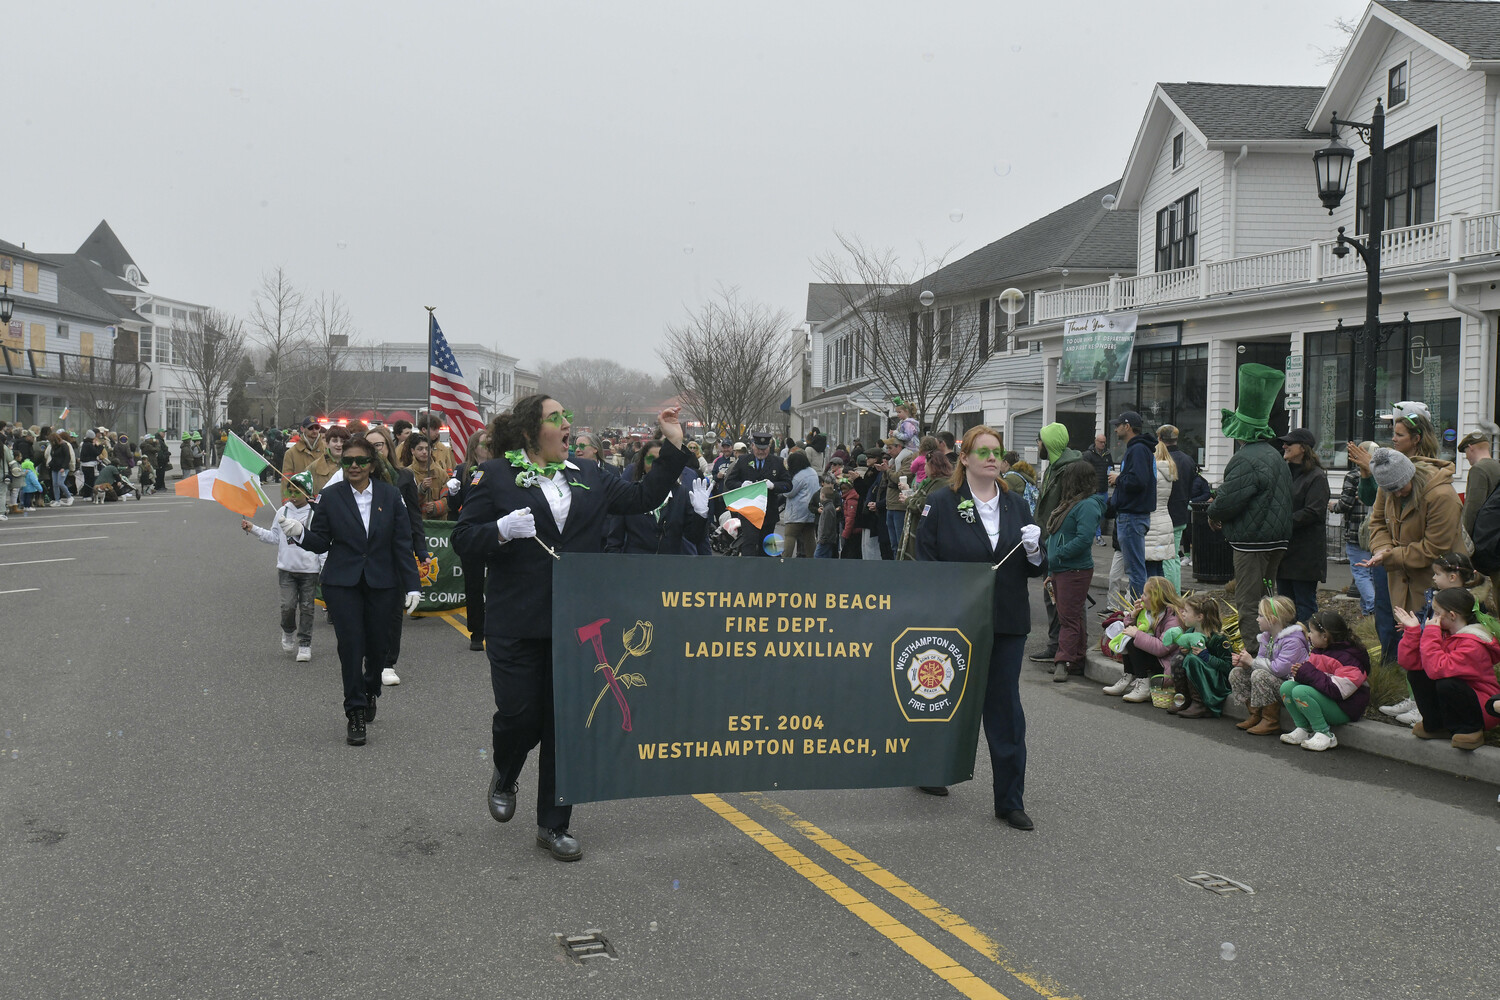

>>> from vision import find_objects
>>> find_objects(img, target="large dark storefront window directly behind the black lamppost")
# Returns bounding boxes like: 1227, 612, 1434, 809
1304, 319, 1460, 469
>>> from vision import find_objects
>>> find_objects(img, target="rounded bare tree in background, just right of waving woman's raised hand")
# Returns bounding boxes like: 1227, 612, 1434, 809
657, 288, 803, 435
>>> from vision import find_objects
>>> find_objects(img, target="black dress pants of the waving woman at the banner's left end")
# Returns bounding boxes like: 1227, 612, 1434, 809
485, 636, 573, 829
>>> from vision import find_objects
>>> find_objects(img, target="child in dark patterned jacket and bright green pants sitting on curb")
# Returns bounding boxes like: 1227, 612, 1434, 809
1281, 612, 1370, 750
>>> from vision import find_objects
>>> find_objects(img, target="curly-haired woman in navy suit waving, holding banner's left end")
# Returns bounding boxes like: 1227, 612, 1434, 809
453, 394, 693, 861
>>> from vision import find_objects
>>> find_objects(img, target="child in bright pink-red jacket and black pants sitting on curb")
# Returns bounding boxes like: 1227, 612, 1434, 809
1392, 588, 1500, 750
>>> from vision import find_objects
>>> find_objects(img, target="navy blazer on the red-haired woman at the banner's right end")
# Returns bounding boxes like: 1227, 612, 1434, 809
917, 483, 1047, 636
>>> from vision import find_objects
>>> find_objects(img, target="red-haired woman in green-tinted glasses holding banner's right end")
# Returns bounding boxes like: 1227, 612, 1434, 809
917, 426, 1047, 831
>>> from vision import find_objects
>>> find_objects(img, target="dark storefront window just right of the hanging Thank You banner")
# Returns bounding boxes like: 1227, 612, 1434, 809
1104, 345, 1209, 465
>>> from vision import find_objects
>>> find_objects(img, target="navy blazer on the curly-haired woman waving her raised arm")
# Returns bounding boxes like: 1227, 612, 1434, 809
453, 441, 692, 639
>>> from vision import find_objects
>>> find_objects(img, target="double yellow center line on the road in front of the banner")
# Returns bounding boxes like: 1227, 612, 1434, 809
693, 792, 1065, 1000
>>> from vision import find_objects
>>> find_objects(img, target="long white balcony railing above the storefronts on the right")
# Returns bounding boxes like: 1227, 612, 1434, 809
1034, 213, 1500, 322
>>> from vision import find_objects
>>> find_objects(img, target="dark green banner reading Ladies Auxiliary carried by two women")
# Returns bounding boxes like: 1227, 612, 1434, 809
552, 553, 995, 804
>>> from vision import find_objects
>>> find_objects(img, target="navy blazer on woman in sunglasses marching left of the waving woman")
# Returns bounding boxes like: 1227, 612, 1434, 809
297, 480, 426, 594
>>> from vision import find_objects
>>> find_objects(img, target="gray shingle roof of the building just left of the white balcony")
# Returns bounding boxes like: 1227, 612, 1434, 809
921, 181, 1139, 295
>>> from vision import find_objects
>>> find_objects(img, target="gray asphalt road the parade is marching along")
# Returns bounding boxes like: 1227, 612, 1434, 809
0, 498, 1500, 1000
